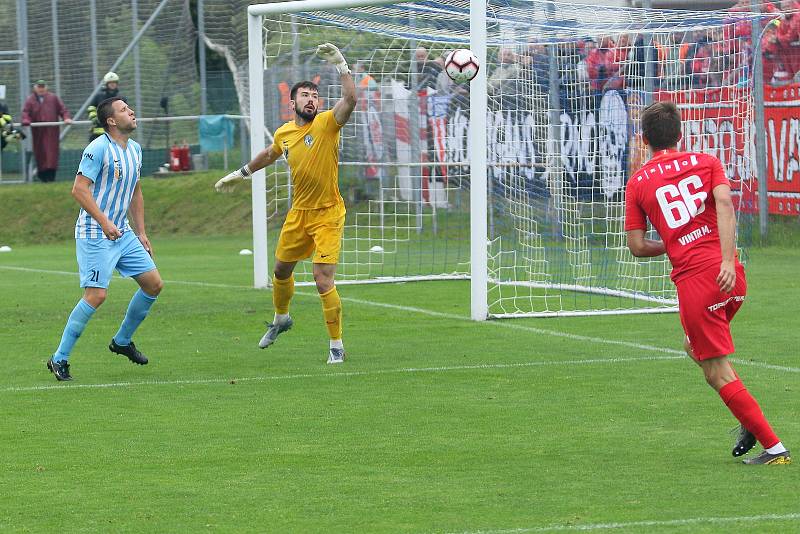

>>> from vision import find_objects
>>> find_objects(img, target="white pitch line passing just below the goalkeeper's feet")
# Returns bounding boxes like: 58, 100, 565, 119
0, 356, 683, 393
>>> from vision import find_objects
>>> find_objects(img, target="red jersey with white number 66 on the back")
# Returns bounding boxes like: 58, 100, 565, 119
625, 150, 730, 282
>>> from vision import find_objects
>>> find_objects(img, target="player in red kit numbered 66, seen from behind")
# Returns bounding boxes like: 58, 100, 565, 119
625, 102, 791, 464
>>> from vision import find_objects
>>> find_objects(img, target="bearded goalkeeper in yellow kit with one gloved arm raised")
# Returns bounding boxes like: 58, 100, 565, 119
214, 43, 356, 363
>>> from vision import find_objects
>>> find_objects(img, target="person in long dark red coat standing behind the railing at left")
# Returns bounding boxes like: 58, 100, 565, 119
22, 80, 72, 182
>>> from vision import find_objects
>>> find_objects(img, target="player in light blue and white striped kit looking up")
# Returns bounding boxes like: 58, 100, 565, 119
47, 98, 164, 381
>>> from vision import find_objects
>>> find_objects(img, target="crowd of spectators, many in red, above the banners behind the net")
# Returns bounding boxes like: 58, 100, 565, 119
456, 0, 800, 98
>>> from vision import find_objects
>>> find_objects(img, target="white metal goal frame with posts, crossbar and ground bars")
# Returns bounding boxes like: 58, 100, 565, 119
247, 0, 692, 321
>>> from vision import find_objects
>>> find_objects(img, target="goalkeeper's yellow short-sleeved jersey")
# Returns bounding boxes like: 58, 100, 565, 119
272, 110, 343, 210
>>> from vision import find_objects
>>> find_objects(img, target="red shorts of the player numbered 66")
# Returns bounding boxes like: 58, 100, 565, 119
677, 262, 747, 360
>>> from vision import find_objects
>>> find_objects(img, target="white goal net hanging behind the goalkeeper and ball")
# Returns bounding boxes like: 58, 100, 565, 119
249, 0, 753, 319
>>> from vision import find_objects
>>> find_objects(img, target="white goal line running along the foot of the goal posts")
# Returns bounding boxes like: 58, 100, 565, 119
0, 265, 800, 373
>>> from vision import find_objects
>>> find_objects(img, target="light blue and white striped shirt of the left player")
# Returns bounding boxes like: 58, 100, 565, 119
75, 133, 142, 239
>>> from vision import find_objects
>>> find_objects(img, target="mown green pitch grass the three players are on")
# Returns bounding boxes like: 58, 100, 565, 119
0, 235, 800, 532
